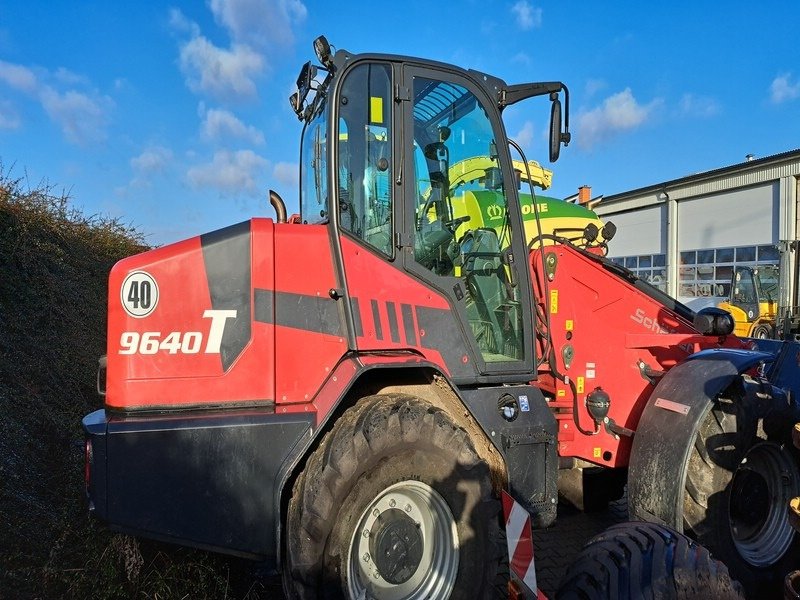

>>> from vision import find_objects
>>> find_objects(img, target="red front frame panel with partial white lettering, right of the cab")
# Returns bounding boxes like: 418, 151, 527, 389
530, 246, 743, 467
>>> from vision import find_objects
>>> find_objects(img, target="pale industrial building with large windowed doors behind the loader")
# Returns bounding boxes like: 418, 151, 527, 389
582, 149, 800, 310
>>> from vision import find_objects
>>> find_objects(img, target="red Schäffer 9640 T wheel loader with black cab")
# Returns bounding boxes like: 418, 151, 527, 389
83, 38, 800, 599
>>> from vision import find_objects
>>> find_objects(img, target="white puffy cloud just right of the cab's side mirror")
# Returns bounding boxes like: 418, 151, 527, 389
575, 88, 662, 148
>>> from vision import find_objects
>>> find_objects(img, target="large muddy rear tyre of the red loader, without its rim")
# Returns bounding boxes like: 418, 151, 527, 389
284, 394, 501, 600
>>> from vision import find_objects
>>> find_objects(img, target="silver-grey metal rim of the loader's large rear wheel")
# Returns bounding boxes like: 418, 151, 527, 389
347, 480, 459, 600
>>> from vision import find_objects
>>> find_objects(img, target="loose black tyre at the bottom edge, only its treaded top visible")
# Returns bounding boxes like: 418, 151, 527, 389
556, 522, 745, 600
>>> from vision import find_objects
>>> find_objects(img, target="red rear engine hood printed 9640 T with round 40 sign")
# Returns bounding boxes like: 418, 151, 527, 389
106, 219, 275, 409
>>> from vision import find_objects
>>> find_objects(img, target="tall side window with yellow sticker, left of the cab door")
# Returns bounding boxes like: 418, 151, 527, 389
338, 64, 392, 255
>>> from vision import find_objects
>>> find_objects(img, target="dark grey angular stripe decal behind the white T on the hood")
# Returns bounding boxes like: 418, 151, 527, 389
200, 221, 251, 371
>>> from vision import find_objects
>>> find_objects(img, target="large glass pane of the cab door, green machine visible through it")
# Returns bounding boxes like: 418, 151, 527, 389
411, 77, 524, 362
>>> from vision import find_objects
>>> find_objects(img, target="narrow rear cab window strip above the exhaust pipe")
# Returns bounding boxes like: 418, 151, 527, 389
300, 103, 329, 223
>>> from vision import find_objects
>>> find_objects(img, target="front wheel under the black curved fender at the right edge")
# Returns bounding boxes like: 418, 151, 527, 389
683, 393, 800, 594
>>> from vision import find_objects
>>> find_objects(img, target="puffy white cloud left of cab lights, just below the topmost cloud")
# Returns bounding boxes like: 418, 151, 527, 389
180, 36, 265, 99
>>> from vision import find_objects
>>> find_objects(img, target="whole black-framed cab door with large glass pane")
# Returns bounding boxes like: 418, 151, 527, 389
398, 65, 535, 380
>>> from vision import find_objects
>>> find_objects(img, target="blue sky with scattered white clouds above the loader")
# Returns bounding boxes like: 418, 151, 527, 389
0, 0, 800, 244
